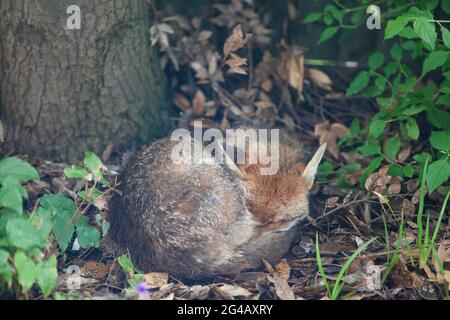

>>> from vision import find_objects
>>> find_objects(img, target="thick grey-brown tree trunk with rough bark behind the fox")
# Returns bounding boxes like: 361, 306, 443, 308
0, 0, 168, 160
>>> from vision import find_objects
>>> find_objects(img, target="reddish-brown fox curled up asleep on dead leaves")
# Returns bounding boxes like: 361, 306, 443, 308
109, 128, 326, 279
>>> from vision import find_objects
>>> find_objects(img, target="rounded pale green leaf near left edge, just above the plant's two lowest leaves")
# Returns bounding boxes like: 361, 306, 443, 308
6, 218, 46, 250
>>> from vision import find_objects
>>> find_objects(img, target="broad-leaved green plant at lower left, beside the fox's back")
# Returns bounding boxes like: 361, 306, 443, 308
0, 152, 110, 297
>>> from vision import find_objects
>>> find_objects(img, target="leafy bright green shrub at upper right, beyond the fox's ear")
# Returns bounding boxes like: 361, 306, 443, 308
304, 0, 450, 193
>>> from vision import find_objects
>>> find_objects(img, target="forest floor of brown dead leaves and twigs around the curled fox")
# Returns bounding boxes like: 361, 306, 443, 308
19, 1, 450, 299
